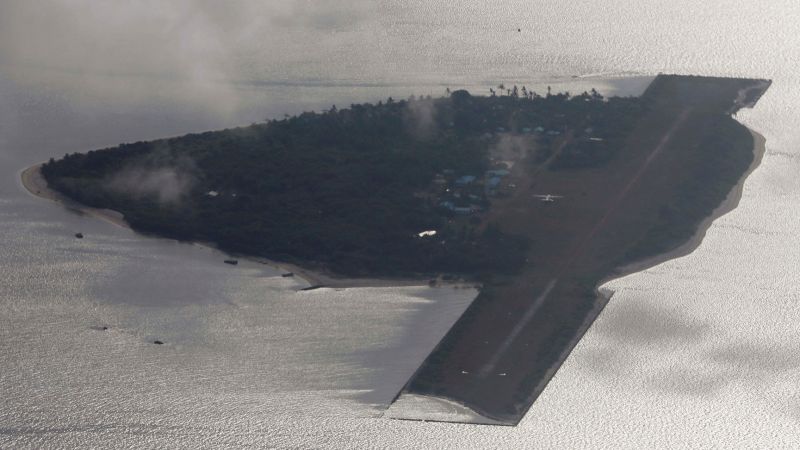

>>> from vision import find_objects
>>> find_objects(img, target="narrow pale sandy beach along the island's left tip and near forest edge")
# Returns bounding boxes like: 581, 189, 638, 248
20, 163, 478, 290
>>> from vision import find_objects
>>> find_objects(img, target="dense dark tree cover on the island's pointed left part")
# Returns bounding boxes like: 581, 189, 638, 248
42, 87, 642, 277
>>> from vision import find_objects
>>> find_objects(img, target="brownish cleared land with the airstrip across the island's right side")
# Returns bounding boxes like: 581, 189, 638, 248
403, 76, 769, 425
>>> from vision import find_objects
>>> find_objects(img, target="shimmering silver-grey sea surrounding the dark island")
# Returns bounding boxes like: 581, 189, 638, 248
0, 0, 800, 449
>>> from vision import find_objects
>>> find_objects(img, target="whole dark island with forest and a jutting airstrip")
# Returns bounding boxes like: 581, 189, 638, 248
26, 75, 770, 425
